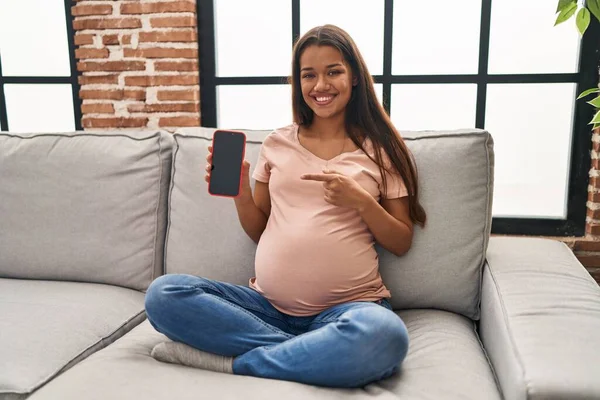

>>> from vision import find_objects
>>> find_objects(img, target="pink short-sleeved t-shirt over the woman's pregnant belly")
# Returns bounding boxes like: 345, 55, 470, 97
249, 124, 407, 316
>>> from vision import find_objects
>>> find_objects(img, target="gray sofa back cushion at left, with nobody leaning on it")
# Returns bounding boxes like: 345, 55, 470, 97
0, 131, 173, 290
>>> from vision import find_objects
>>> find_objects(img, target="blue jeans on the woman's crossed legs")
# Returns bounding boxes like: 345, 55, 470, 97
146, 274, 408, 388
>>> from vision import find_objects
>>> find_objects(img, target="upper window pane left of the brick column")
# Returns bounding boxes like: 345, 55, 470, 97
0, 0, 71, 76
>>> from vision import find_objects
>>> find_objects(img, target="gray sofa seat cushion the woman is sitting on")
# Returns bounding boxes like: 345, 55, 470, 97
30, 310, 500, 400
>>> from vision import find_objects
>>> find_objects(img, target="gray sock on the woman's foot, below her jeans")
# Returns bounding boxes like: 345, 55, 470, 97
150, 342, 233, 374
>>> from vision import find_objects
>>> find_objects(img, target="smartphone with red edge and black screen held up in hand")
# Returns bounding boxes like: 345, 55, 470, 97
208, 129, 246, 197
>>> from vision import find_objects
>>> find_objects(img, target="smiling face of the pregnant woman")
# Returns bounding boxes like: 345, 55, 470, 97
300, 45, 357, 122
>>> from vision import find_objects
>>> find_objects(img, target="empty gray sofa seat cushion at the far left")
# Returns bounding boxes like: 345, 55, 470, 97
0, 279, 145, 399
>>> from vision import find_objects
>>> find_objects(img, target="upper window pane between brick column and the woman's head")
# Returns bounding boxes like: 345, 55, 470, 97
215, 0, 292, 76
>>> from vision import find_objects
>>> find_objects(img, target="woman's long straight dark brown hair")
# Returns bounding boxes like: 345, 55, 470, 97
290, 25, 427, 227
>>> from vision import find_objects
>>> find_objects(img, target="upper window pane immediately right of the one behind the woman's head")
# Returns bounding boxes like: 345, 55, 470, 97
392, 0, 480, 75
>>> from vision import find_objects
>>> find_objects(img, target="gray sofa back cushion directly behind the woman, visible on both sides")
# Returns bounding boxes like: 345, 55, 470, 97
165, 128, 494, 319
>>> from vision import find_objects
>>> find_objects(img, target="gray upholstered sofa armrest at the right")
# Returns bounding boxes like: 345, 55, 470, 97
479, 237, 600, 400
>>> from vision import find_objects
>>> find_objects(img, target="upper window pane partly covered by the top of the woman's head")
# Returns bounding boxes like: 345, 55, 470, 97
300, 0, 384, 75
